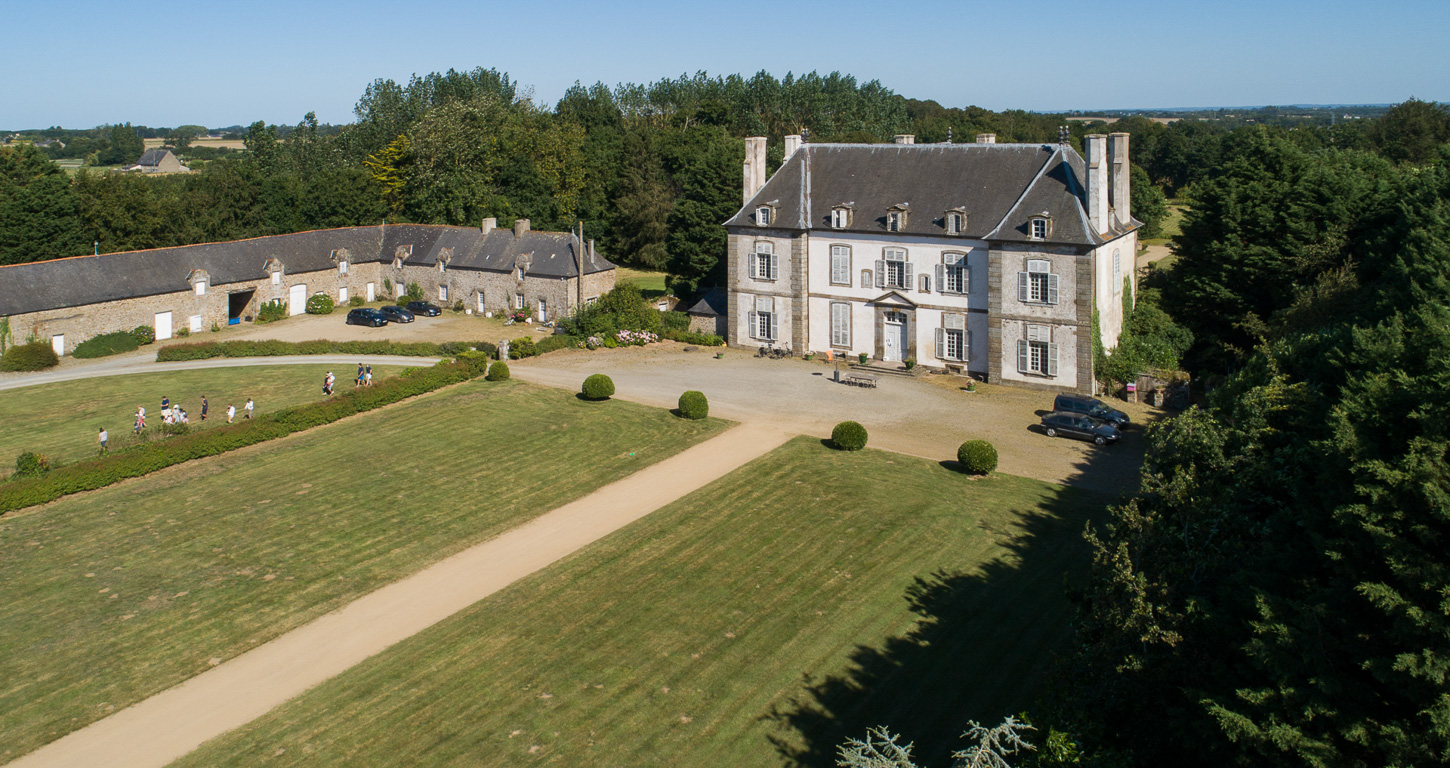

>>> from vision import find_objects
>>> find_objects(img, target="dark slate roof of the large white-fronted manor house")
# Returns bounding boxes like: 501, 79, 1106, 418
725, 143, 1127, 245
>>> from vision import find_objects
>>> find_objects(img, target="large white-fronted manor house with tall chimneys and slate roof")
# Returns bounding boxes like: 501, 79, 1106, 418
725, 133, 1141, 393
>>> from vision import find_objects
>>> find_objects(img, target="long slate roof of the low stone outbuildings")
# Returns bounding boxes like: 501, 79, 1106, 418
0, 225, 615, 316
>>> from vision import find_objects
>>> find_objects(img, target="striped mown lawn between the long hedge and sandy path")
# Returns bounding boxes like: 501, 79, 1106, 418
0, 381, 724, 762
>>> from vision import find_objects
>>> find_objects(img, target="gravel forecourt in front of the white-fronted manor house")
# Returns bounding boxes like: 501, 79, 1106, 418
512, 342, 1159, 493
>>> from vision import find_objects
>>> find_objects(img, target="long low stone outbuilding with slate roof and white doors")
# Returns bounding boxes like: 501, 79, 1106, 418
0, 219, 615, 355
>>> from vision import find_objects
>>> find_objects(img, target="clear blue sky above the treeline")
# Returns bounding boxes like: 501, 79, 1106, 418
0, 0, 1450, 129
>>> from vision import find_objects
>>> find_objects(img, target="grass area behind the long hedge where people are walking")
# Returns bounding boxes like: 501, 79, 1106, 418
0, 364, 403, 477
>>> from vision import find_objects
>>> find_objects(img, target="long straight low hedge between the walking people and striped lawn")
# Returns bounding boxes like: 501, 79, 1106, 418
0, 361, 479, 514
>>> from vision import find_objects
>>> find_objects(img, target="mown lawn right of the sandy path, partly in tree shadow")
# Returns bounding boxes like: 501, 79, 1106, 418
178, 438, 1105, 768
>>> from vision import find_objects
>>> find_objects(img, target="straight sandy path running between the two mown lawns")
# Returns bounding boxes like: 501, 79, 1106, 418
9, 423, 790, 768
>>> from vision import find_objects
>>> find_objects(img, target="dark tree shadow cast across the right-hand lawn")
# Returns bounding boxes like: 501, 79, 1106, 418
763, 486, 1109, 768
